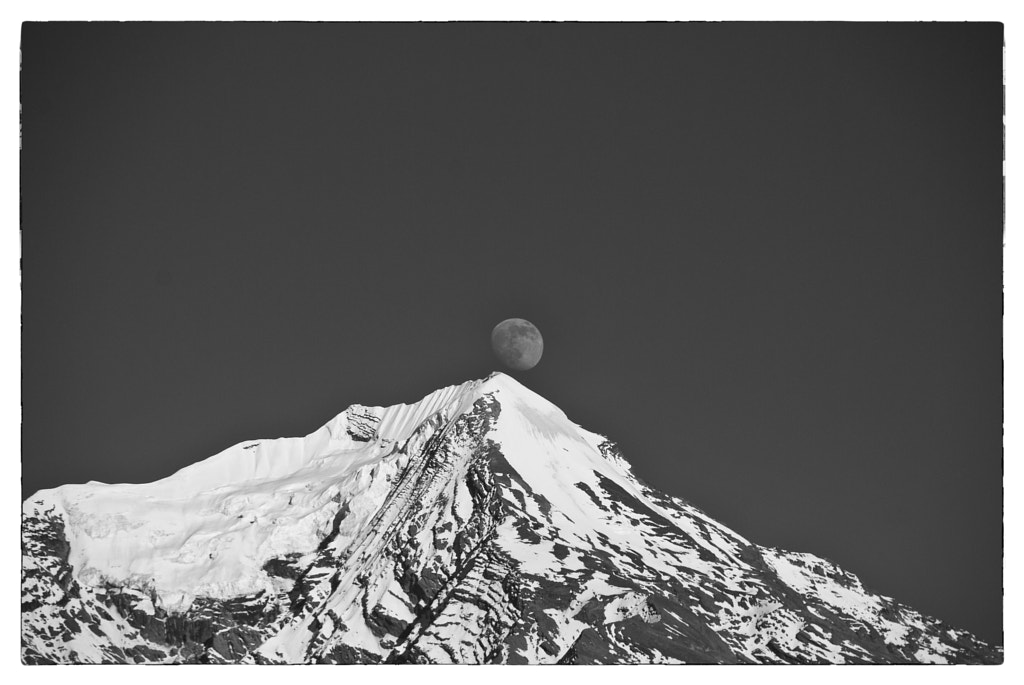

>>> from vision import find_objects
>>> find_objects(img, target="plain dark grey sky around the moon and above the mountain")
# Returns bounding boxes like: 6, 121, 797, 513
22, 24, 1002, 642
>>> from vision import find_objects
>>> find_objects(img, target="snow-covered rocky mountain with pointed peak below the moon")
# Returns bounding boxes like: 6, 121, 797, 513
22, 374, 1002, 663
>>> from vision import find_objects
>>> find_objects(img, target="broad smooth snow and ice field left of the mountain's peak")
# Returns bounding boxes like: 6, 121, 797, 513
25, 381, 480, 610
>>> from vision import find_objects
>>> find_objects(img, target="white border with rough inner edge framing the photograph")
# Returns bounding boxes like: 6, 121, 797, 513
0, 5, 1024, 683
